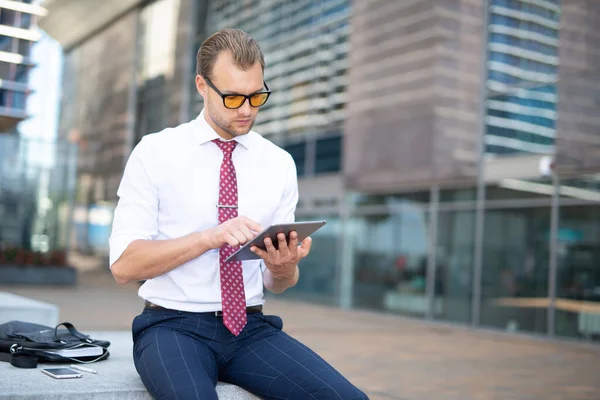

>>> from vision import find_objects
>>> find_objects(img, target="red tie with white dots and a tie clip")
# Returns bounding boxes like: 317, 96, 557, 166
213, 139, 246, 336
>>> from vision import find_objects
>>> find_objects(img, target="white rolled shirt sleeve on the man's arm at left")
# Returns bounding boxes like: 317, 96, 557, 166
109, 140, 158, 267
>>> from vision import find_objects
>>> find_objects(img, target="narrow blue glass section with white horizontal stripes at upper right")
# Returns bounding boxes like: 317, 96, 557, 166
485, 0, 560, 154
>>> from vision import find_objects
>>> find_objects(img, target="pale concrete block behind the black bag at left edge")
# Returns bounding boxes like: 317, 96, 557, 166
0, 292, 58, 327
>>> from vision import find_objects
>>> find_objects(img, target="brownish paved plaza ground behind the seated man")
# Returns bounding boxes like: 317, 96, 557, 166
0, 272, 600, 400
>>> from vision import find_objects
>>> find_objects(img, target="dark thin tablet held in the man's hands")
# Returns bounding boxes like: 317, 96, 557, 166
225, 220, 327, 262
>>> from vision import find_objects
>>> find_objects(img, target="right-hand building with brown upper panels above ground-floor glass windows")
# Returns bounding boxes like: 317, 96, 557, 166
341, 0, 600, 340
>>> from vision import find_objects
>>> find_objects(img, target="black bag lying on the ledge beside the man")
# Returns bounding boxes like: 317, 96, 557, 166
0, 321, 110, 368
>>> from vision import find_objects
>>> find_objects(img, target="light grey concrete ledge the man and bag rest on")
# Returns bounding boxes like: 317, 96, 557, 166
0, 331, 258, 400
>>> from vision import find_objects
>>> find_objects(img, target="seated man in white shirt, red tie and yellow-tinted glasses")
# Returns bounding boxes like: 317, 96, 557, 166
110, 29, 367, 400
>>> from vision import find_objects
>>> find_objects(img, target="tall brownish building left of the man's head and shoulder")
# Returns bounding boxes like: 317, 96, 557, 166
40, 0, 202, 257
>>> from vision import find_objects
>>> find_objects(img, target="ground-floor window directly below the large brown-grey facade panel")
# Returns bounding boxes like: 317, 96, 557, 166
353, 203, 429, 316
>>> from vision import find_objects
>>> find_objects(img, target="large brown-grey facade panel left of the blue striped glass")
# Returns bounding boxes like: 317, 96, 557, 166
344, 0, 484, 191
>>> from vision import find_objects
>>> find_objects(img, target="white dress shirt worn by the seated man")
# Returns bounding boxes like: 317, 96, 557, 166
110, 111, 298, 312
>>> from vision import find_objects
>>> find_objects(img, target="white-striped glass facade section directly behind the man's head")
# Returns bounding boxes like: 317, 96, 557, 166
194, 0, 350, 177
